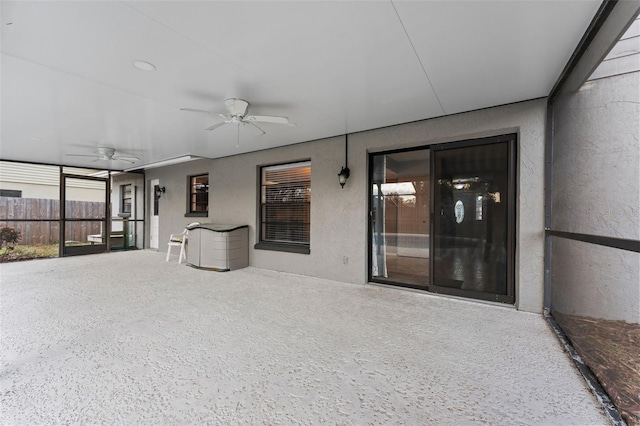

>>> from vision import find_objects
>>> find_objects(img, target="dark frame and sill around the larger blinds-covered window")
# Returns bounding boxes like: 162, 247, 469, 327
254, 159, 311, 254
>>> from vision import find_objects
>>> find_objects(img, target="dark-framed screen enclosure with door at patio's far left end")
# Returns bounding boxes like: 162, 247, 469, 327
0, 161, 145, 261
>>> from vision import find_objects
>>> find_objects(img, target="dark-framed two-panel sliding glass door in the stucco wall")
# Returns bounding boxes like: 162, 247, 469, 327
369, 135, 516, 303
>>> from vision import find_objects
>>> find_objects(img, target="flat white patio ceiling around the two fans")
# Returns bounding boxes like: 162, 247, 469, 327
0, 0, 600, 169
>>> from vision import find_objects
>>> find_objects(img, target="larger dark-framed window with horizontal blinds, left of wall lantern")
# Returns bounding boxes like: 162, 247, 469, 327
260, 161, 311, 248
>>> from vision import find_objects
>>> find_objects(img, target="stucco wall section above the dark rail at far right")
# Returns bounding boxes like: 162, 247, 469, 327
552, 73, 640, 240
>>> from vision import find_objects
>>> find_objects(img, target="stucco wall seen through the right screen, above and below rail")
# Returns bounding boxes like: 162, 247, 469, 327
551, 73, 640, 322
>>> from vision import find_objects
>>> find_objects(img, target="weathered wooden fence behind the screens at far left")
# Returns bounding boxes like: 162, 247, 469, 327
0, 197, 106, 245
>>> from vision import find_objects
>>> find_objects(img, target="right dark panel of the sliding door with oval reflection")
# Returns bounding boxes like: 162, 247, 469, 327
431, 136, 515, 303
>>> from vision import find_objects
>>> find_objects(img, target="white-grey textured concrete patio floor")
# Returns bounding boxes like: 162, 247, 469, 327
0, 251, 607, 425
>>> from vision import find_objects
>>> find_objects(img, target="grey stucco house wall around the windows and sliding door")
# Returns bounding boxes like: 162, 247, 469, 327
146, 99, 546, 312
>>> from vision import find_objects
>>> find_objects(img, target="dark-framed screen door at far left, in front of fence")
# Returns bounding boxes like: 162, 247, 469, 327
61, 174, 109, 256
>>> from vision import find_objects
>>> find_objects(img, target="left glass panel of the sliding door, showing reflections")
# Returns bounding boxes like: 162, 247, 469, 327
370, 149, 431, 288
